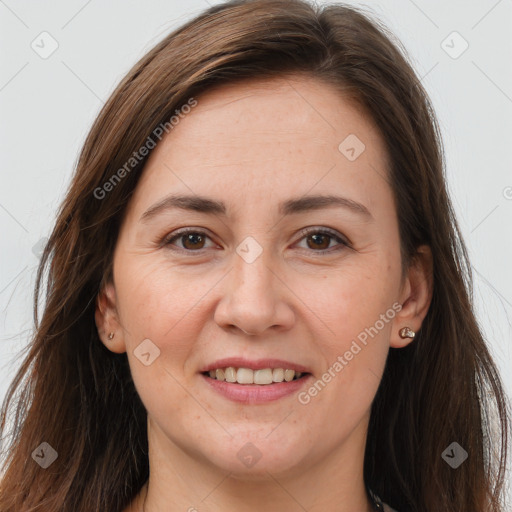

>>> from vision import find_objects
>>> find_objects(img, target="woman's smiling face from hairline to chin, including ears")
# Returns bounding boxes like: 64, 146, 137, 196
96, 78, 432, 477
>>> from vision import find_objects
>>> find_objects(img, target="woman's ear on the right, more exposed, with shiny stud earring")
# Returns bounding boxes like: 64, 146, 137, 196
390, 245, 433, 348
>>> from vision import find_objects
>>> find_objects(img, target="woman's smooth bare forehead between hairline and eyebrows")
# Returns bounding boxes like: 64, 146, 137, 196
127, 77, 386, 218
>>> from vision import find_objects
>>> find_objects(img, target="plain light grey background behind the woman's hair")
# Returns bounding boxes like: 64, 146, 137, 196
0, 0, 512, 498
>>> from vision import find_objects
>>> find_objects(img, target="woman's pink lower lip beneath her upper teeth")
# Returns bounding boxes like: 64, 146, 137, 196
201, 374, 312, 404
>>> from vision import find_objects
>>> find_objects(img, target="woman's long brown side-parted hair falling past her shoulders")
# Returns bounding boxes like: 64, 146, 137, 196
0, 0, 510, 512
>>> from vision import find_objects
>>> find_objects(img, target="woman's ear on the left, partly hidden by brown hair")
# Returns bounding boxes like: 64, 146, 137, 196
94, 282, 126, 354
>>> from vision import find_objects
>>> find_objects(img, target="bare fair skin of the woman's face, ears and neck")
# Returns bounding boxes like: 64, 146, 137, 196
96, 76, 432, 512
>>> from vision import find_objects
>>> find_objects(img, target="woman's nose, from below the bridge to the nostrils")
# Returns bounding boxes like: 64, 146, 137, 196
214, 250, 295, 335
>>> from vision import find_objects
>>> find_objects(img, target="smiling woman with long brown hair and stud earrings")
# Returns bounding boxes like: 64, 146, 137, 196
0, 0, 508, 512
